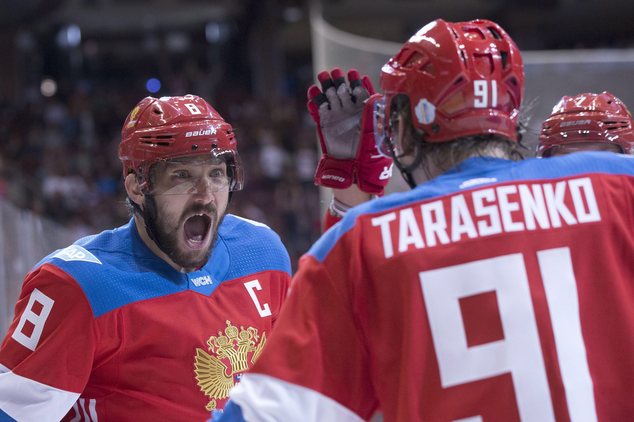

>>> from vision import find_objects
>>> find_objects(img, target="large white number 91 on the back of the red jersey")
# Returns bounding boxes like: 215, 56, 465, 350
419, 248, 597, 422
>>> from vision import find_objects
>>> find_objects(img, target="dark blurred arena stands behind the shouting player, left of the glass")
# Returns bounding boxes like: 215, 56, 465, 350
0, 1, 321, 270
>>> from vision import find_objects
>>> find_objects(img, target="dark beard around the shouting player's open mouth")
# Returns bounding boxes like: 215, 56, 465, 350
143, 195, 225, 271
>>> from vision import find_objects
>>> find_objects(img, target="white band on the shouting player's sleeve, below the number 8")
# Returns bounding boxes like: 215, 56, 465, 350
0, 364, 79, 422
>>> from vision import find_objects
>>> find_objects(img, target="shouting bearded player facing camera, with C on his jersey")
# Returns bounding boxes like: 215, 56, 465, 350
0, 95, 290, 421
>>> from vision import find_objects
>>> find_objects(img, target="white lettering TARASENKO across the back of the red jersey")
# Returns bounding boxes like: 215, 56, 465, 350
371, 177, 601, 258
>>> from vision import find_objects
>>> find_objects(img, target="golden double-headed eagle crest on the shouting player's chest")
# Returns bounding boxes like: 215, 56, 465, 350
194, 320, 266, 410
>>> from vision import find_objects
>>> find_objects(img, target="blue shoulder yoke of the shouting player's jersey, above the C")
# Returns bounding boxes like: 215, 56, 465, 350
38, 215, 291, 317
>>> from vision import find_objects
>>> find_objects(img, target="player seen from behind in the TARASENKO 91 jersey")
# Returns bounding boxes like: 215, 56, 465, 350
215, 20, 634, 422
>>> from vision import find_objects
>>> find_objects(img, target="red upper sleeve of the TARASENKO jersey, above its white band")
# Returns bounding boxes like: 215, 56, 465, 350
252, 255, 376, 419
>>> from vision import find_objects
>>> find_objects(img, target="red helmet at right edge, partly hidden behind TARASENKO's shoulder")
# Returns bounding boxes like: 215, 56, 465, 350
537, 91, 634, 157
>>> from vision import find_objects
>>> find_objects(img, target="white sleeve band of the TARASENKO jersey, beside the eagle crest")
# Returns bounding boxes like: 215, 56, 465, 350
229, 374, 363, 422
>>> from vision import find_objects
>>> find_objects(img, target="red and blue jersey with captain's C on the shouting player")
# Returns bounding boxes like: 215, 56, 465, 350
0, 215, 290, 422
